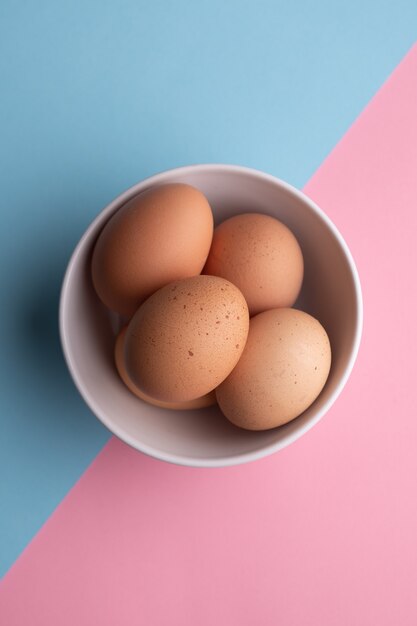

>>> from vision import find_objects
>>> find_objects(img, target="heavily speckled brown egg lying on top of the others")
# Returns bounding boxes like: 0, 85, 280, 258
125, 276, 249, 402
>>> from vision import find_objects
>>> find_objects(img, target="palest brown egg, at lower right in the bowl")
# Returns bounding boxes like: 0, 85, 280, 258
216, 309, 331, 430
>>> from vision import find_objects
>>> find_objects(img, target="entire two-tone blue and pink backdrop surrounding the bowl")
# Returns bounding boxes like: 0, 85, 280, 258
0, 0, 417, 626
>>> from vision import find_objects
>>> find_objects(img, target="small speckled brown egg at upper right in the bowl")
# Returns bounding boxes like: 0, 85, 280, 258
203, 213, 304, 316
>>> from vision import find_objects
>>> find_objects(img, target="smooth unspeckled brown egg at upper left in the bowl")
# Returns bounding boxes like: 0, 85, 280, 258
92, 183, 213, 317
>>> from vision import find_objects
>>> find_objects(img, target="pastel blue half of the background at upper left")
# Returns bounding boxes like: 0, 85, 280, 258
0, 0, 417, 574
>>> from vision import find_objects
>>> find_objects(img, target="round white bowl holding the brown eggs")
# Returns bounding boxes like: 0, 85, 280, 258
60, 165, 362, 467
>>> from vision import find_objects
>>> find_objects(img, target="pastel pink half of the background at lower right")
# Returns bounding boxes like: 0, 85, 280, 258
0, 47, 417, 626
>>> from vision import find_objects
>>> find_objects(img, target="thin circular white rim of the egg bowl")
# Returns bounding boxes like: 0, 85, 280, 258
59, 163, 363, 467
